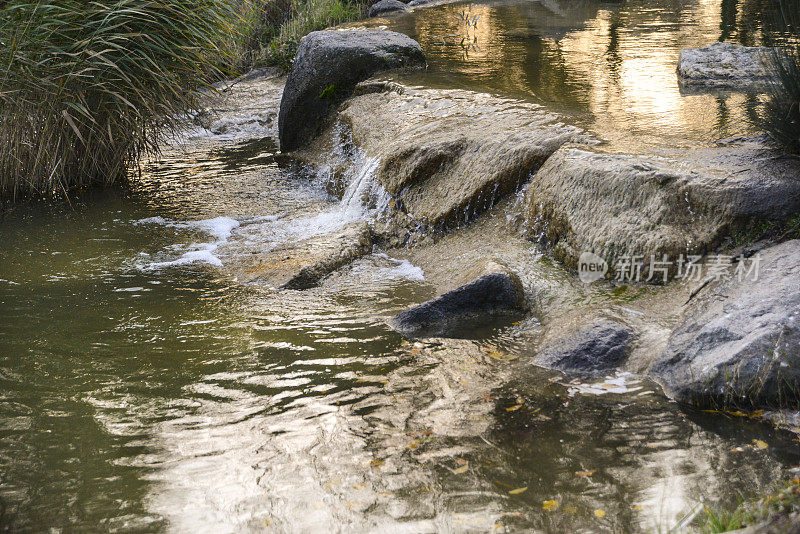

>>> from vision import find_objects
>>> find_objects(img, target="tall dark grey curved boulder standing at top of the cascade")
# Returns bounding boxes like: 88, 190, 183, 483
278, 30, 425, 152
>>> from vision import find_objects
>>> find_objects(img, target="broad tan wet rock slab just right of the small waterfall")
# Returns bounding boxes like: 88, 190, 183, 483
328, 84, 583, 233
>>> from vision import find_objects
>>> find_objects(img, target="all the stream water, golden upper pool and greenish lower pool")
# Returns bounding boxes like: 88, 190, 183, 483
0, 0, 800, 532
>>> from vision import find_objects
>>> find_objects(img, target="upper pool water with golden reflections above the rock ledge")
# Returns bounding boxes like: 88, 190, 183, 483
359, 0, 776, 149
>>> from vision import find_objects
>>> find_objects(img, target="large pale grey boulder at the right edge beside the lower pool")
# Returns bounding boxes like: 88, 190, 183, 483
650, 240, 800, 407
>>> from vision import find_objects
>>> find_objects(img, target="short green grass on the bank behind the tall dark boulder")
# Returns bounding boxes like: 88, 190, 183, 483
243, 0, 368, 69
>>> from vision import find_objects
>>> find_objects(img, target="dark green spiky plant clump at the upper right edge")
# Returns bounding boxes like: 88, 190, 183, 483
757, 0, 800, 154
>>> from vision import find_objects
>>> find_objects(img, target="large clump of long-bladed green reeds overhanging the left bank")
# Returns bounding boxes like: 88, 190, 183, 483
0, 0, 236, 198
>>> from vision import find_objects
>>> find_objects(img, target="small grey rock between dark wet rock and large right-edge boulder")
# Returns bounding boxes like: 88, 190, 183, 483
533, 319, 634, 373
